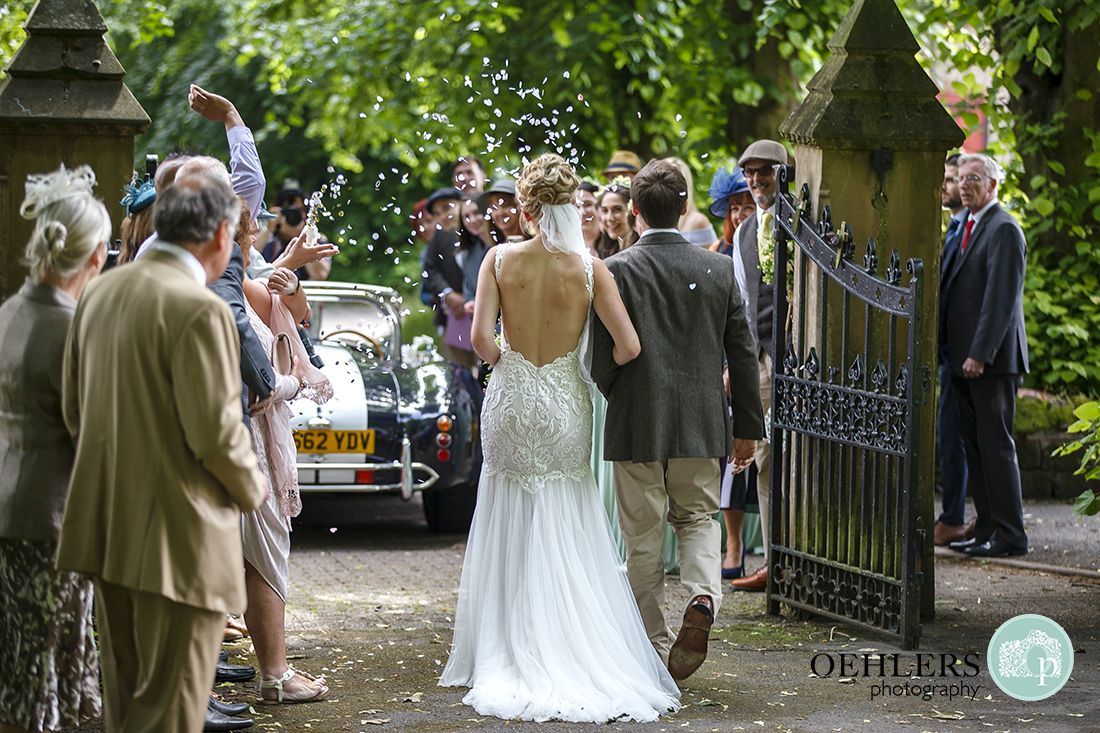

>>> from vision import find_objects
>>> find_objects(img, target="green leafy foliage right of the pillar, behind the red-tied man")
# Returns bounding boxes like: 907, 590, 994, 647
909, 0, 1100, 395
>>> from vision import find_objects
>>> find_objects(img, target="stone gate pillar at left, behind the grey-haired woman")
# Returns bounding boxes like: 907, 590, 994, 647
0, 0, 150, 299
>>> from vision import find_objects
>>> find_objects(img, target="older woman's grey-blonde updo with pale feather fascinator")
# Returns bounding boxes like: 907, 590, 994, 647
19, 165, 111, 283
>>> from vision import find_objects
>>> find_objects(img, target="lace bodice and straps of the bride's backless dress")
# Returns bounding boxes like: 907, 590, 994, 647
482, 245, 592, 493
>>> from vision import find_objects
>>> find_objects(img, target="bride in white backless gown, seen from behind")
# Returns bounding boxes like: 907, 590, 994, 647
439, 154, 680, 723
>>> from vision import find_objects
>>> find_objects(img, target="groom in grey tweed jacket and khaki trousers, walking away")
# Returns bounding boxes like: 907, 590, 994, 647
592, 161, 763, 679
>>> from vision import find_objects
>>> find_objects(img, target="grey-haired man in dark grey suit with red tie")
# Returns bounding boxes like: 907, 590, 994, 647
939, 155, 1027, 557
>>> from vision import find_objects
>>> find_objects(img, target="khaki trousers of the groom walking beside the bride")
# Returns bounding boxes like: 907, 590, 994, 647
615, 458, 722, 664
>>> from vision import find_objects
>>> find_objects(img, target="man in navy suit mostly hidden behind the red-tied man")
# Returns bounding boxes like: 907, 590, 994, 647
933, 153, 975, 546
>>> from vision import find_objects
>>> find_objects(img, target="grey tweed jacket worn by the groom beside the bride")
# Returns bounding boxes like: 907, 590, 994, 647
592, 232, 763, 463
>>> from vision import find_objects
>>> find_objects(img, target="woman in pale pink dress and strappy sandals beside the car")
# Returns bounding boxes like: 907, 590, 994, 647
235, 206, 332, 702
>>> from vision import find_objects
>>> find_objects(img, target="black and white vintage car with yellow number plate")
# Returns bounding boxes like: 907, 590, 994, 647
292, 281, 482, 532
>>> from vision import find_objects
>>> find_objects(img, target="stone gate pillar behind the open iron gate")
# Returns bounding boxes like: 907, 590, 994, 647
779, 0, 965, 621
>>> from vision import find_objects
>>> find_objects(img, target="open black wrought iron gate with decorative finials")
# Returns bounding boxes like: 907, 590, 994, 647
768, 166, 931, 649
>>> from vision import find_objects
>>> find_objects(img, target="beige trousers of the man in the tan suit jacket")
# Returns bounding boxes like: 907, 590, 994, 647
96, 579, 226, 733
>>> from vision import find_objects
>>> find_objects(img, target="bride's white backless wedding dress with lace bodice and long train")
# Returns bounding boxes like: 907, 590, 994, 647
439, 245, 680, 723
